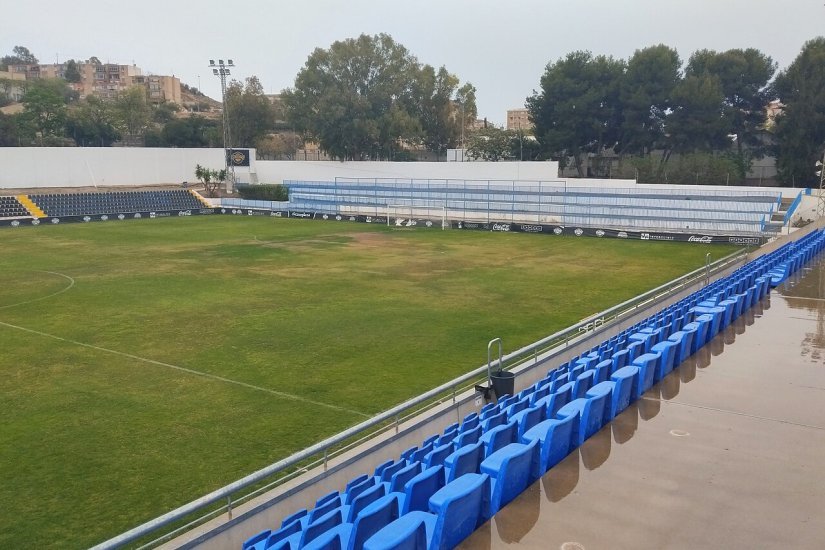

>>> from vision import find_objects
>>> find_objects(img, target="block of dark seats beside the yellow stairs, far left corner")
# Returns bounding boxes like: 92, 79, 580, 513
29, 189, 204, 217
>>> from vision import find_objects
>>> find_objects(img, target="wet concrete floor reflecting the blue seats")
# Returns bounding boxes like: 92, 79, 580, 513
459, 258, 825, 550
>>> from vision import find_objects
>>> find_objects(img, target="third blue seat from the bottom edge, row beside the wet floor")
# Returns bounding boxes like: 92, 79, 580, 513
481, 440, 538, 517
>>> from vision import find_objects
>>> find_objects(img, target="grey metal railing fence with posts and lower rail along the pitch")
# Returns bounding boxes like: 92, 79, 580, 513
91, 249, 748, 550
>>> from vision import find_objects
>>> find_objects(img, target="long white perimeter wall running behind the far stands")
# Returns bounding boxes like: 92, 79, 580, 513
0, 147, 800, 197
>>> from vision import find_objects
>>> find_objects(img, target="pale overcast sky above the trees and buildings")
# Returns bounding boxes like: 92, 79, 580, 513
0, 0, 825, 123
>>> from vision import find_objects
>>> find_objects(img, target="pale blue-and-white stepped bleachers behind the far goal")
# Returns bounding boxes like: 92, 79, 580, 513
285, 180, 781, 233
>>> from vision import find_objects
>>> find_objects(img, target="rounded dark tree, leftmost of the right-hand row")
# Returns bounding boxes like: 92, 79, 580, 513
527, 51, 625, 178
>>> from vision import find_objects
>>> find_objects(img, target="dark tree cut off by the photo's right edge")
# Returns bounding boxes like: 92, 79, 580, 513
774, 37, 825, 187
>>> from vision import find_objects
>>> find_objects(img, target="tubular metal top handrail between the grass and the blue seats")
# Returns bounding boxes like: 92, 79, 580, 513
90, 248, 747, 550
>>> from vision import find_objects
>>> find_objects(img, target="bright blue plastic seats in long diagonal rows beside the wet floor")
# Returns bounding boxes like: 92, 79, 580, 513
233, 227, 825, 550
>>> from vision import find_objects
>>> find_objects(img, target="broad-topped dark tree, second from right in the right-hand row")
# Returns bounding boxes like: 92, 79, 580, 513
685, 48, 776, 182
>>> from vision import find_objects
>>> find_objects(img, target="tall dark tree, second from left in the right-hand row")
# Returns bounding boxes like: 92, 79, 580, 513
619, 44, 682, 155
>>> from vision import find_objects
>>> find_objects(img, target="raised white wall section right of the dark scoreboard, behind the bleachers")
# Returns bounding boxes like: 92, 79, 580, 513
255, 160, 559, 183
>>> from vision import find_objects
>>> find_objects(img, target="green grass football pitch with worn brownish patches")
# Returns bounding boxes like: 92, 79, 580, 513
0, 216, 731, 550
